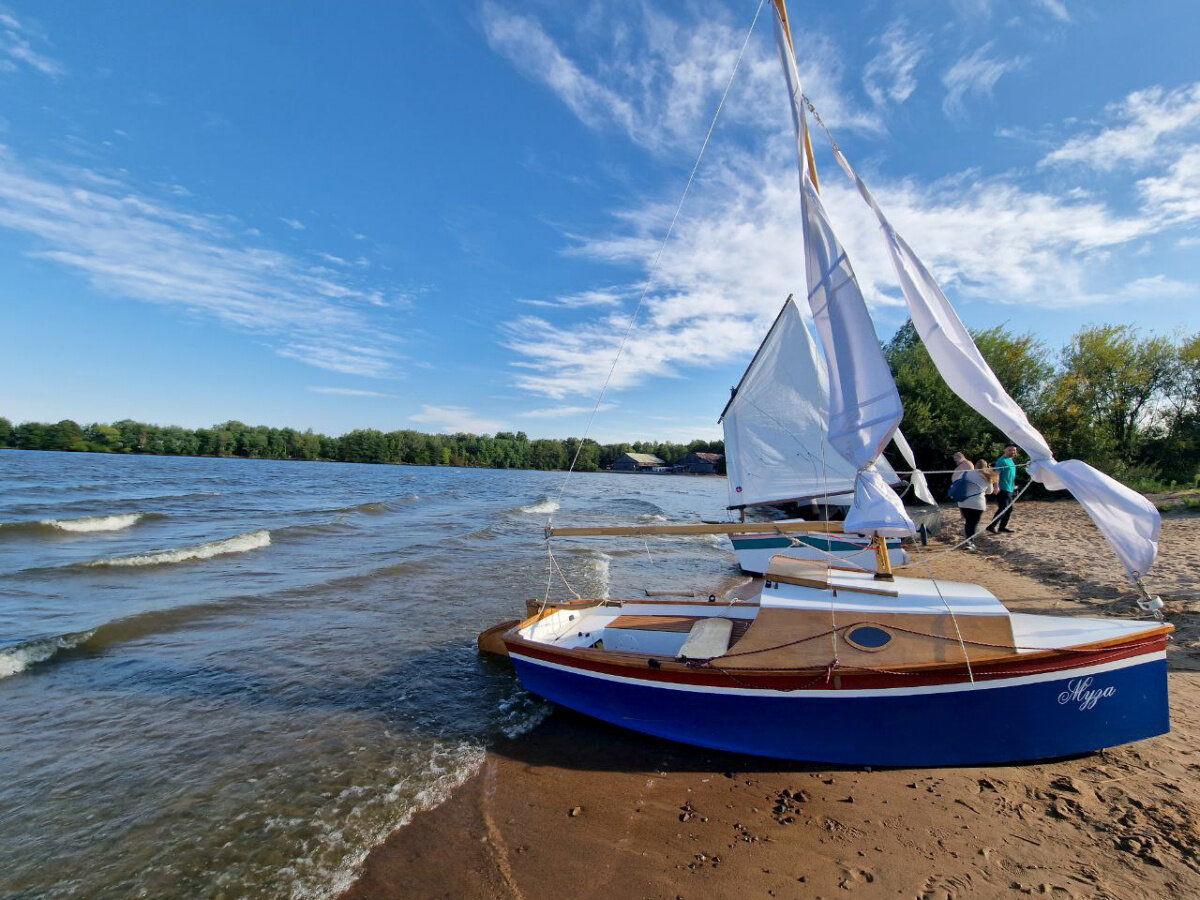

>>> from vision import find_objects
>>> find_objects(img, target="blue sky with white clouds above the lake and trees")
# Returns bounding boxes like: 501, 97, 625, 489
0, 0, 1200, 440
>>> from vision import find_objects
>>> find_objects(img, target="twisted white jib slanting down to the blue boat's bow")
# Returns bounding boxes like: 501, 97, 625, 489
834, 146, 1162, 584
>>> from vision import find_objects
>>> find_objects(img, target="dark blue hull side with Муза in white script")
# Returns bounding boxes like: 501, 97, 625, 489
512, 653, 1170, 766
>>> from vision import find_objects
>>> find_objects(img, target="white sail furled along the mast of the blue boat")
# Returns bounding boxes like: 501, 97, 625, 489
775, 16, 917, 535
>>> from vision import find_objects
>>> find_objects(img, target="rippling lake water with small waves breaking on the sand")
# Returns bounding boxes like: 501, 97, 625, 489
0, 451, 737, 898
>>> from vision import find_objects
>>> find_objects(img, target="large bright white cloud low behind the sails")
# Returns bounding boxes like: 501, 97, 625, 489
504, 150, 1177, 400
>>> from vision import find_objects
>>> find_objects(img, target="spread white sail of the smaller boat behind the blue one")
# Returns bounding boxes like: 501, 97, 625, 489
720, 298, 898, 506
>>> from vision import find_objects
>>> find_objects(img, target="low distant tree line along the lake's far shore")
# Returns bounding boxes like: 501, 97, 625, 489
0, 418, 724, 472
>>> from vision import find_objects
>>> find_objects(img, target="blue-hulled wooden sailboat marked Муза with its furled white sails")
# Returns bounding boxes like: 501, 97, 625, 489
480, 0, 1172, 766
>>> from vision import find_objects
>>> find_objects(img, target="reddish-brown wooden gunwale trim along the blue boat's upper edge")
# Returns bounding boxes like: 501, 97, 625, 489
504, 625, 1175, 689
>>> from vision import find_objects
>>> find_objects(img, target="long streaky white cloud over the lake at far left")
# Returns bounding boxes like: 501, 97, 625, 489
0, 150, 397, 376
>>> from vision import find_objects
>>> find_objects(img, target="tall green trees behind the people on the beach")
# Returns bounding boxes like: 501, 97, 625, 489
883, 322, 1200, 491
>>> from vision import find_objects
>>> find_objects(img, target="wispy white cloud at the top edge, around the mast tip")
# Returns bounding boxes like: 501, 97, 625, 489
481, 0, 882, 152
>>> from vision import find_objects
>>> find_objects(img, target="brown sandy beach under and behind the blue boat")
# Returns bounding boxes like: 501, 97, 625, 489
343, 502, 1200, 900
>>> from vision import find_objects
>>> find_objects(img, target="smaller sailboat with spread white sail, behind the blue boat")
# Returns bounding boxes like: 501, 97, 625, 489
718, 296, 936, 575
